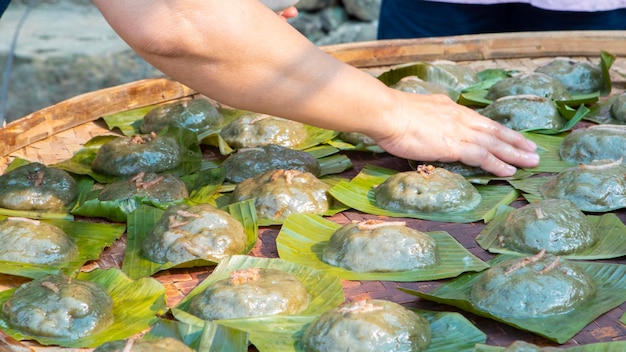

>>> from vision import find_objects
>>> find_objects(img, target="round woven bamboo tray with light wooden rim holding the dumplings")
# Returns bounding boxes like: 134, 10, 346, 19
0, 31, 626, 351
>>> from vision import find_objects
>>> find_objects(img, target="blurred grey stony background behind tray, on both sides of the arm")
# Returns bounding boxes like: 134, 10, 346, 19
0, 0, 381, 126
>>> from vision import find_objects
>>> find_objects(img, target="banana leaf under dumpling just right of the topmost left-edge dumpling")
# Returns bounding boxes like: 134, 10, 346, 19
71, 168, 224, 222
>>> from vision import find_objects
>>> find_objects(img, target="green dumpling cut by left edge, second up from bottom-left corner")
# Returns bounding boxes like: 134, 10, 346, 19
0, 217, 78, 265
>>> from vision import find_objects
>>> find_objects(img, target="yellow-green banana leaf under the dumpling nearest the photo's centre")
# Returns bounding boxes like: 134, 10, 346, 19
276, 214, 488, 282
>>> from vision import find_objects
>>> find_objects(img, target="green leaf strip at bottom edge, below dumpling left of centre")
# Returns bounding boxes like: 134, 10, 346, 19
143, 319, 249, 352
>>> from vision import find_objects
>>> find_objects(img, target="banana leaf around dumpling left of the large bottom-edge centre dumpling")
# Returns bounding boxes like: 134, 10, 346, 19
172, 255, 345, 343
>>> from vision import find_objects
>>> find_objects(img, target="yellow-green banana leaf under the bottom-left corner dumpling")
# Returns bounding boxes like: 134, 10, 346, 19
0, 269, 166, 348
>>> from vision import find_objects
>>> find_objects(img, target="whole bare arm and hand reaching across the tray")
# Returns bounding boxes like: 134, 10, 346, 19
94, 0, 539, 176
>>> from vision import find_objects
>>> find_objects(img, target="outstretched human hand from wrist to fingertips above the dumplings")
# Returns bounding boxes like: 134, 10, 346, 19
370, 91, 539, 176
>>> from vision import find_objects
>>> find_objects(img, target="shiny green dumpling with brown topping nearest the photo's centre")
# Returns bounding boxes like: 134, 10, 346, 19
322, 220, 438, 272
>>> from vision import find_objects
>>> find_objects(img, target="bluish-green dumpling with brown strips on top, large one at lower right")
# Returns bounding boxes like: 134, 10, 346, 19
470, 251, 596, 318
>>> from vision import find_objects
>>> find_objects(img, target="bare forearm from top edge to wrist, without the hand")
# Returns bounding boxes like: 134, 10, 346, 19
95, 0, 394, 138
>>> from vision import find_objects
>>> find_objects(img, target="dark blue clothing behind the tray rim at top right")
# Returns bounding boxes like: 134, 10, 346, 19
378, 0, 626, 39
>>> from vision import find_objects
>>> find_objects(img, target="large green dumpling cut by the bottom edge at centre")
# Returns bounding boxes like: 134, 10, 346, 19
300, 299, 431, 352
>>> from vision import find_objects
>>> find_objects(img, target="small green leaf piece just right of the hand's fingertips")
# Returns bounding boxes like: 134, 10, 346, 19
522, 132, 576, 173
